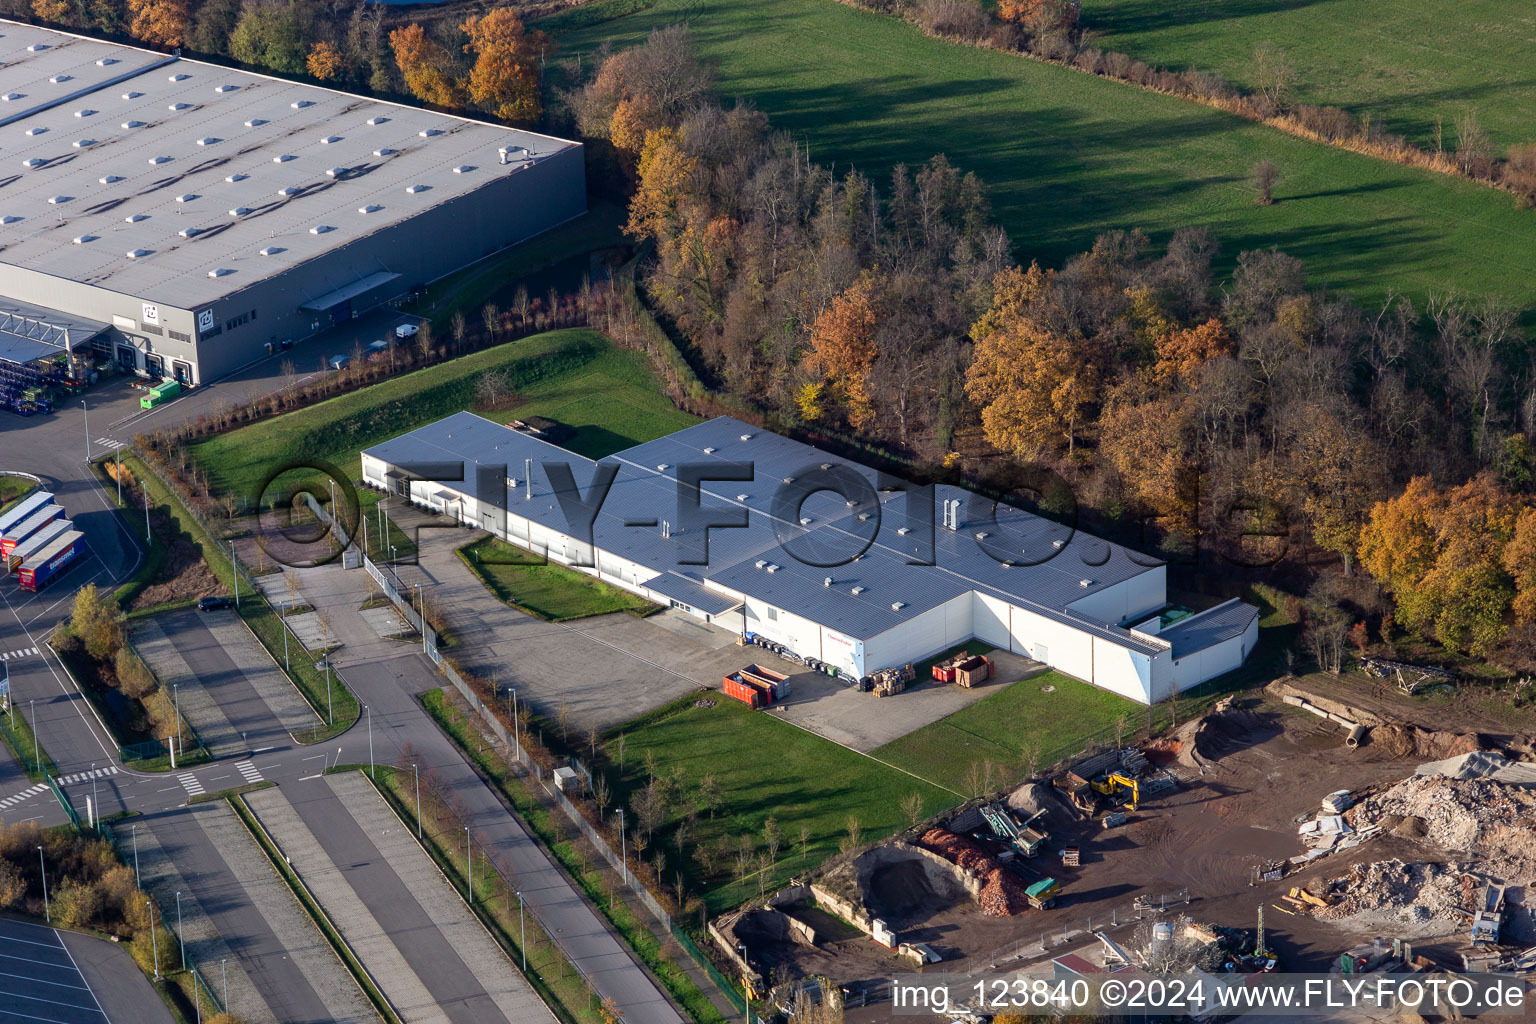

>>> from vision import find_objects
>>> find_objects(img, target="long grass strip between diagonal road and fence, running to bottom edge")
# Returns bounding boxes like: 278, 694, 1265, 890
421, 689, 723, 1024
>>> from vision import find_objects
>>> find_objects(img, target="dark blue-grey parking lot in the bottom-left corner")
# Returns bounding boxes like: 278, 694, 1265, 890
0, 920, 170, 1024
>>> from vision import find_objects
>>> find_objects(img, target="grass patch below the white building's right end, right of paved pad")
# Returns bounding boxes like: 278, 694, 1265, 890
874, 672, 1146, 794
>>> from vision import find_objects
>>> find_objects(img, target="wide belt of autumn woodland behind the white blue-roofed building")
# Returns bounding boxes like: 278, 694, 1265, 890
562, 26, 1536, 669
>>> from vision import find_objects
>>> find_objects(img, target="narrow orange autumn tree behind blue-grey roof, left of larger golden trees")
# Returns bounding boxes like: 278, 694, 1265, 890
800, 272, 880, 428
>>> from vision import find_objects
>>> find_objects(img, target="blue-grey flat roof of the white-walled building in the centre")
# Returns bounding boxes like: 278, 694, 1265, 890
367, 413, 1166, 654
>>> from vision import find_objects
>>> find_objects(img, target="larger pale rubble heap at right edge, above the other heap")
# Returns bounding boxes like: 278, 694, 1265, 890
1347, 775, 1536, 854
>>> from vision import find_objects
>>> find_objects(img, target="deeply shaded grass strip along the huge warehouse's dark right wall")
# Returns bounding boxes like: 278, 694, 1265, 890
402, 201, 628, 323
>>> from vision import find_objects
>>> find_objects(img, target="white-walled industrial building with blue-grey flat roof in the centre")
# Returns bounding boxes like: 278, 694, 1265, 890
362, 413, 1258, 703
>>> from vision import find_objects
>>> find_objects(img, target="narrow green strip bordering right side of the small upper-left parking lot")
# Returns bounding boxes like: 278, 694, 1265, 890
123, 457, 361, 743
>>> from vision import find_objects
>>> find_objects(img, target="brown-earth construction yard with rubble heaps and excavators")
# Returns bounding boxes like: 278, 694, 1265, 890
711, 666, 1536, 1021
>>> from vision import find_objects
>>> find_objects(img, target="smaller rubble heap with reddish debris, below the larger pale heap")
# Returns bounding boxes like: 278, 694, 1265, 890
1316, 860, 1481, 935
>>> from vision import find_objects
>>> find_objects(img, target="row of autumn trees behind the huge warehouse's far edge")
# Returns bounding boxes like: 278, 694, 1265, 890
9, 0, 553, 124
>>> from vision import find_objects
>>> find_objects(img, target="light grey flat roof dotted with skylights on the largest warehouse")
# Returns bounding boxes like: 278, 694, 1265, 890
0, 21, 574, 309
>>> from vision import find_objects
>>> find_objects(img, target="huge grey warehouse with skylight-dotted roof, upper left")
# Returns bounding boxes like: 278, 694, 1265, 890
0, 21, 585, 384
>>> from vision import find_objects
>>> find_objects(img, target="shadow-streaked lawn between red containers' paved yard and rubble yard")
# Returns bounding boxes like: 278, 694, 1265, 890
605, 691, 958, 913
